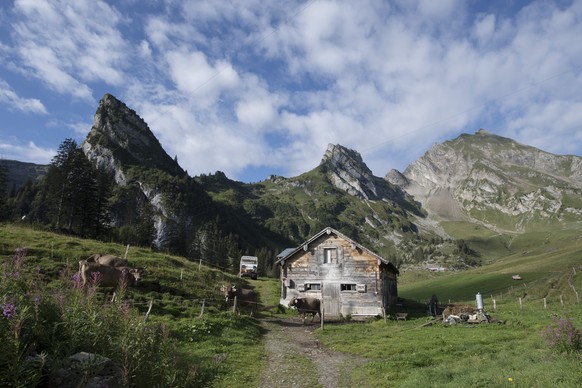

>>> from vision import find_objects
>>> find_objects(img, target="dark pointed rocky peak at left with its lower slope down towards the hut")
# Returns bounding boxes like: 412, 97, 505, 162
82, 94, 286, 260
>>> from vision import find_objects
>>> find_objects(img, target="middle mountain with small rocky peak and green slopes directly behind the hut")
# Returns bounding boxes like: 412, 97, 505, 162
197, 144, 463, 265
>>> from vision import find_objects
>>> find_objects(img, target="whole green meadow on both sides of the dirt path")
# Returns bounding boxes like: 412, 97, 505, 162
0, 225, 582, 387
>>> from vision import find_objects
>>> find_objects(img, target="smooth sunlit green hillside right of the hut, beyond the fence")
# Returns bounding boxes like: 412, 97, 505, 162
399, 224, 582, 302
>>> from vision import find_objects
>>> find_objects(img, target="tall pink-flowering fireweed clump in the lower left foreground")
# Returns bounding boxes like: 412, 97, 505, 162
0, 248, 196, 387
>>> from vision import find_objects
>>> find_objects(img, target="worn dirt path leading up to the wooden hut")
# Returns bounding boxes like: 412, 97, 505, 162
260, 318, 366, 388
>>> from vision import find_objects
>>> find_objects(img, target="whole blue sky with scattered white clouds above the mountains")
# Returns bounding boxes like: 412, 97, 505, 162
0, 0, 582, 182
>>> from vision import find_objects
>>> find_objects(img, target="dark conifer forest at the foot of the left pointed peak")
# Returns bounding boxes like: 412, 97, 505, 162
0, 139, 276, 276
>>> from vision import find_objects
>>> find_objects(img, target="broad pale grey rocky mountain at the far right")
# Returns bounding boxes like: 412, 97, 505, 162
386, 130, 582, 232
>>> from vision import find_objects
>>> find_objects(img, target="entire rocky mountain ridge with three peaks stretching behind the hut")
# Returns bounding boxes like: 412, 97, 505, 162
4, 94, 582, 267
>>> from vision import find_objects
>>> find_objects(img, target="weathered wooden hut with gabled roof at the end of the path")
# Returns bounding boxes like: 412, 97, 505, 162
277, 227, 399, 319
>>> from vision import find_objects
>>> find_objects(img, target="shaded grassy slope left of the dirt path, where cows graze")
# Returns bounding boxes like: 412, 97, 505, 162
0, 225, 288, 386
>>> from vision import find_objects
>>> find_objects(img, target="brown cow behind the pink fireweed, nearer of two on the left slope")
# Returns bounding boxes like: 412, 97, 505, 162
81, 262, 145, 287
